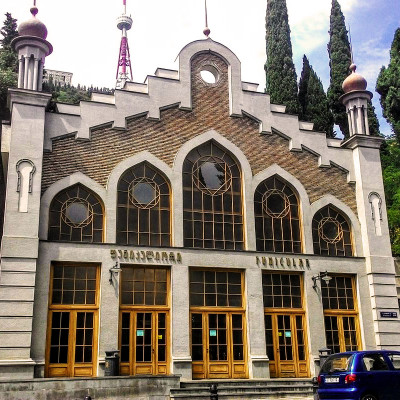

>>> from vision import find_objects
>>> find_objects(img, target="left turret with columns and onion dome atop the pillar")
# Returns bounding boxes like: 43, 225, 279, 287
12, 0, 53, 91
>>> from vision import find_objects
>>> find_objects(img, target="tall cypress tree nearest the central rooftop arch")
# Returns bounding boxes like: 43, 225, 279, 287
264, 0, 300, 114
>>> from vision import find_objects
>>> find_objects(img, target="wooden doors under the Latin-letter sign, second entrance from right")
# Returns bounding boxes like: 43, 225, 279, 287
265, 313, 309, 378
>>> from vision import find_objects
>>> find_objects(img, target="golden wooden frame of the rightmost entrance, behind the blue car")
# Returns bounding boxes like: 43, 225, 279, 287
321, 273, 362, 352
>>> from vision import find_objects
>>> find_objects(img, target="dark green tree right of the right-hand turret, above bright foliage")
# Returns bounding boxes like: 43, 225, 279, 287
376, 28, 400, 143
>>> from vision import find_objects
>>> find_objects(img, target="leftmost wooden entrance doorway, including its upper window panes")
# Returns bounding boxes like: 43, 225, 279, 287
45, 263, 99, 377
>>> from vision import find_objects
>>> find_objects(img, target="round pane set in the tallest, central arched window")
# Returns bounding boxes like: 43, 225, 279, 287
192, 156, 232, 196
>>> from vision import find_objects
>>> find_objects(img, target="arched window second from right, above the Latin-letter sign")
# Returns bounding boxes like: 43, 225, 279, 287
254, 176, 301, 253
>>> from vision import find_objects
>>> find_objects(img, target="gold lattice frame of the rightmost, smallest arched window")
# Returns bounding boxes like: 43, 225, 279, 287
311, 203, 356, 257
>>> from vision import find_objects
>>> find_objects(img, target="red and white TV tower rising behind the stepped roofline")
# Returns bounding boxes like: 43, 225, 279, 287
116, 0, 133, 89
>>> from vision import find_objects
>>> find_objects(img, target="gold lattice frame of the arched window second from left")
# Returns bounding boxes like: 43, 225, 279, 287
115, 160, 174, 247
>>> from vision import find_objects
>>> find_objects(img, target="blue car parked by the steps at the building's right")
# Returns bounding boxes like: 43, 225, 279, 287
318, 350, 400, 400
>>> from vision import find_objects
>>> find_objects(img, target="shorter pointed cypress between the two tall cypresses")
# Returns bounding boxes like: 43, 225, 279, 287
299, 56, 334, 137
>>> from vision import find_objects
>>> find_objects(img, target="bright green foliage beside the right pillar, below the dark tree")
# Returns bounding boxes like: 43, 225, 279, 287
381, 138, 400, 255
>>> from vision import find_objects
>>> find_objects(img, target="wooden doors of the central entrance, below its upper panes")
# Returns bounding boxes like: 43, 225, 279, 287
191, 312, 247, 379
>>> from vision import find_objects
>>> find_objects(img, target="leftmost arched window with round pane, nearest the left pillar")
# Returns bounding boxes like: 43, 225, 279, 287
49, 184, 104, 243
